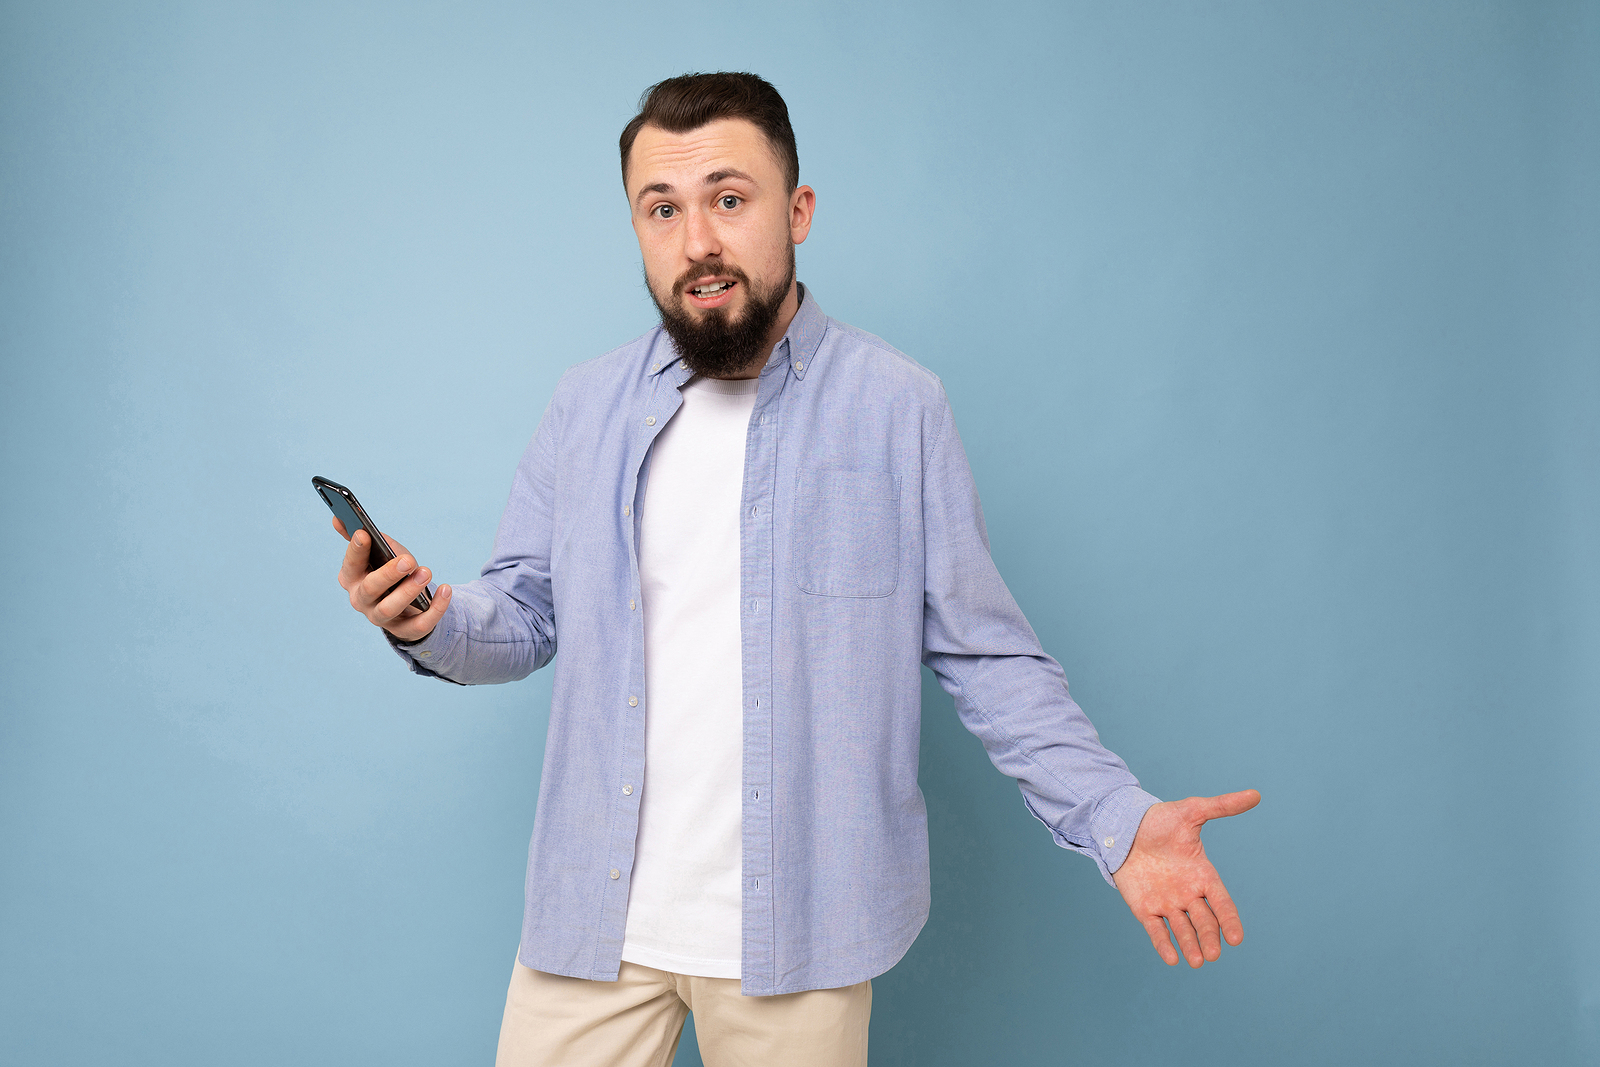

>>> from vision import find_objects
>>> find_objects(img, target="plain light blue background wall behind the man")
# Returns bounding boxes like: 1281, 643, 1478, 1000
0, 0, 1600, 1067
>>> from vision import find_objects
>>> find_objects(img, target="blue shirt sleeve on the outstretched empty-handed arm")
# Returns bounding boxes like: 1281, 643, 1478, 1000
923, 392, 1160, 885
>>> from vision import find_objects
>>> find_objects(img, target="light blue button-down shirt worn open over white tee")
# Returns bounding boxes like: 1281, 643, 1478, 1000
390, 286, 1157, 995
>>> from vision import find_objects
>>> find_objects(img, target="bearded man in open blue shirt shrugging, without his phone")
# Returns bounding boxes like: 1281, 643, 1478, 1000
334, 74, 1259, 1067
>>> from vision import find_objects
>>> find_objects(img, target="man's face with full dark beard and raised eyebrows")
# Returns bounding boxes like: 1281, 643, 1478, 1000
627, 118, 814, 376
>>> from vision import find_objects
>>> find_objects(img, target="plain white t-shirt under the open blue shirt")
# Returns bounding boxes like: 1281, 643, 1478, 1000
622, 378, 758, 977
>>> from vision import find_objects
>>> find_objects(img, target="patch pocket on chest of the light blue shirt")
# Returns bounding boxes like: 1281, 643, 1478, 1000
790, 469, 901, 597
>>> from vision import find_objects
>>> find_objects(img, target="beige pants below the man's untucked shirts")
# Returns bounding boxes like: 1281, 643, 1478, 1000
494, 960, 872, 1067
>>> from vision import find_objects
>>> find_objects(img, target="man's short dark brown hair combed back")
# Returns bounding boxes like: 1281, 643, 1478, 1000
618, 70, 800, 192
